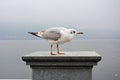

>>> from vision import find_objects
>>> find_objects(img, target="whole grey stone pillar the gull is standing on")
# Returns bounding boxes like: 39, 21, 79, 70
22, 51, 101, 80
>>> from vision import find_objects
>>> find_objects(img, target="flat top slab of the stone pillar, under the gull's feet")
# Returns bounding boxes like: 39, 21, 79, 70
22, 51, 101, 62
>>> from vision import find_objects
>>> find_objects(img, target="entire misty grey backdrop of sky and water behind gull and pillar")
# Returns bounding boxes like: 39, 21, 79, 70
0, 0, 120, 80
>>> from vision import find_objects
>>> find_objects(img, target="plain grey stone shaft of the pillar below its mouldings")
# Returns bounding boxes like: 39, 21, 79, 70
32, 67, 92, 80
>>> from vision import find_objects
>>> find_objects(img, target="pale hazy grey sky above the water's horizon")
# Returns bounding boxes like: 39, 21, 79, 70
0, 0, 120, 39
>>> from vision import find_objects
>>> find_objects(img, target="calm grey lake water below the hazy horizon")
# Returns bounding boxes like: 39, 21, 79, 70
0, 39, 120, 80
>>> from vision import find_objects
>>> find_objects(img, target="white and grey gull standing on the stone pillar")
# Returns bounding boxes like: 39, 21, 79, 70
28, 27, 83, 55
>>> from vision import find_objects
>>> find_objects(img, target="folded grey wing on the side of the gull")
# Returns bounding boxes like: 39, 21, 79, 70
42, 29, 61, 41
